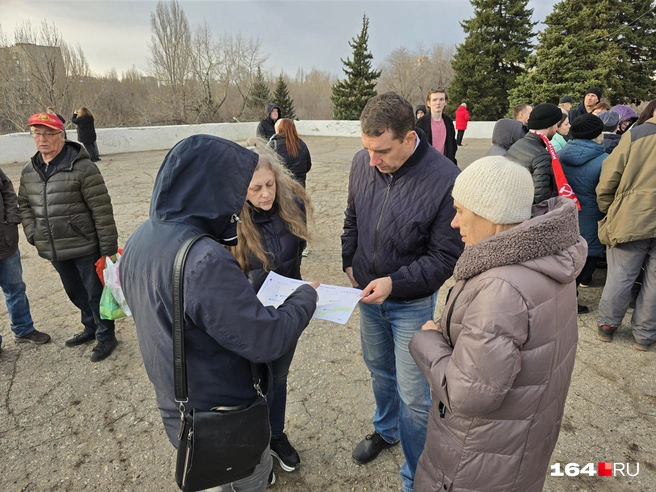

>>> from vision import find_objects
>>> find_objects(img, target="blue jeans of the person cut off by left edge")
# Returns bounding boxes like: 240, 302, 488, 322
0, 249, 34, 345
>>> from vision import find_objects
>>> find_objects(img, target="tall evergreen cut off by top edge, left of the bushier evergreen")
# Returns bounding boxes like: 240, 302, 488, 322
447, 0, 536, 120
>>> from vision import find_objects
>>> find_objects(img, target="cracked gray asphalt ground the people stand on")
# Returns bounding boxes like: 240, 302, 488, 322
0, 136, 656, 492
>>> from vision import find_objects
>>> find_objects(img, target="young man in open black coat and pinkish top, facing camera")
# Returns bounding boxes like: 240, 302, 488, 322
417, 87, 458, 165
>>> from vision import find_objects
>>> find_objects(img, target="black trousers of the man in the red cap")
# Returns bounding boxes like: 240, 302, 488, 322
52, 253, 114, 342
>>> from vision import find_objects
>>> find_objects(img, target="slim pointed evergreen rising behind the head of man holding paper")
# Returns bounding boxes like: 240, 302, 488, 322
330, 15, 381, 120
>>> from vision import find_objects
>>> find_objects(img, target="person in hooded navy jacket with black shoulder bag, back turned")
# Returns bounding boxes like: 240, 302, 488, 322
120, 135, 318, 491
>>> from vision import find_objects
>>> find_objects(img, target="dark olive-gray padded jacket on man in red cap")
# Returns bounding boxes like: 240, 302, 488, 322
18, 141, 118, 261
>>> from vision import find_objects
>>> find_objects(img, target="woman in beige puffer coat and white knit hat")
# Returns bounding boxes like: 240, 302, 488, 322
410, 157, 587, 492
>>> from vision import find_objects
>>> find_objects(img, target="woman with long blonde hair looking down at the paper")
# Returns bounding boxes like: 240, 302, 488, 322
228, 141, 313, 472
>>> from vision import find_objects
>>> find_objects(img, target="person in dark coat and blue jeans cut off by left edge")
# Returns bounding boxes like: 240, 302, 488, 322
0, 169, 50, 352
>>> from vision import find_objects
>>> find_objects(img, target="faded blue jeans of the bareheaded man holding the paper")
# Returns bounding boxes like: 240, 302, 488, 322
360, 292, 437, 492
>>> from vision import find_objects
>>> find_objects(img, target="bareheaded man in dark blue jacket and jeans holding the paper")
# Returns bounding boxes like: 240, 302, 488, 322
342, 92, 463, 492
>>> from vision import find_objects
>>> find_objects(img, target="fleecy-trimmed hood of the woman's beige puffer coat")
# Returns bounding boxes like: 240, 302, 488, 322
453, 197, 587, 284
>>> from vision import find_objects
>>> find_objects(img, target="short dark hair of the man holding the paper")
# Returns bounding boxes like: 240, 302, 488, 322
360, 92, 415, 141
